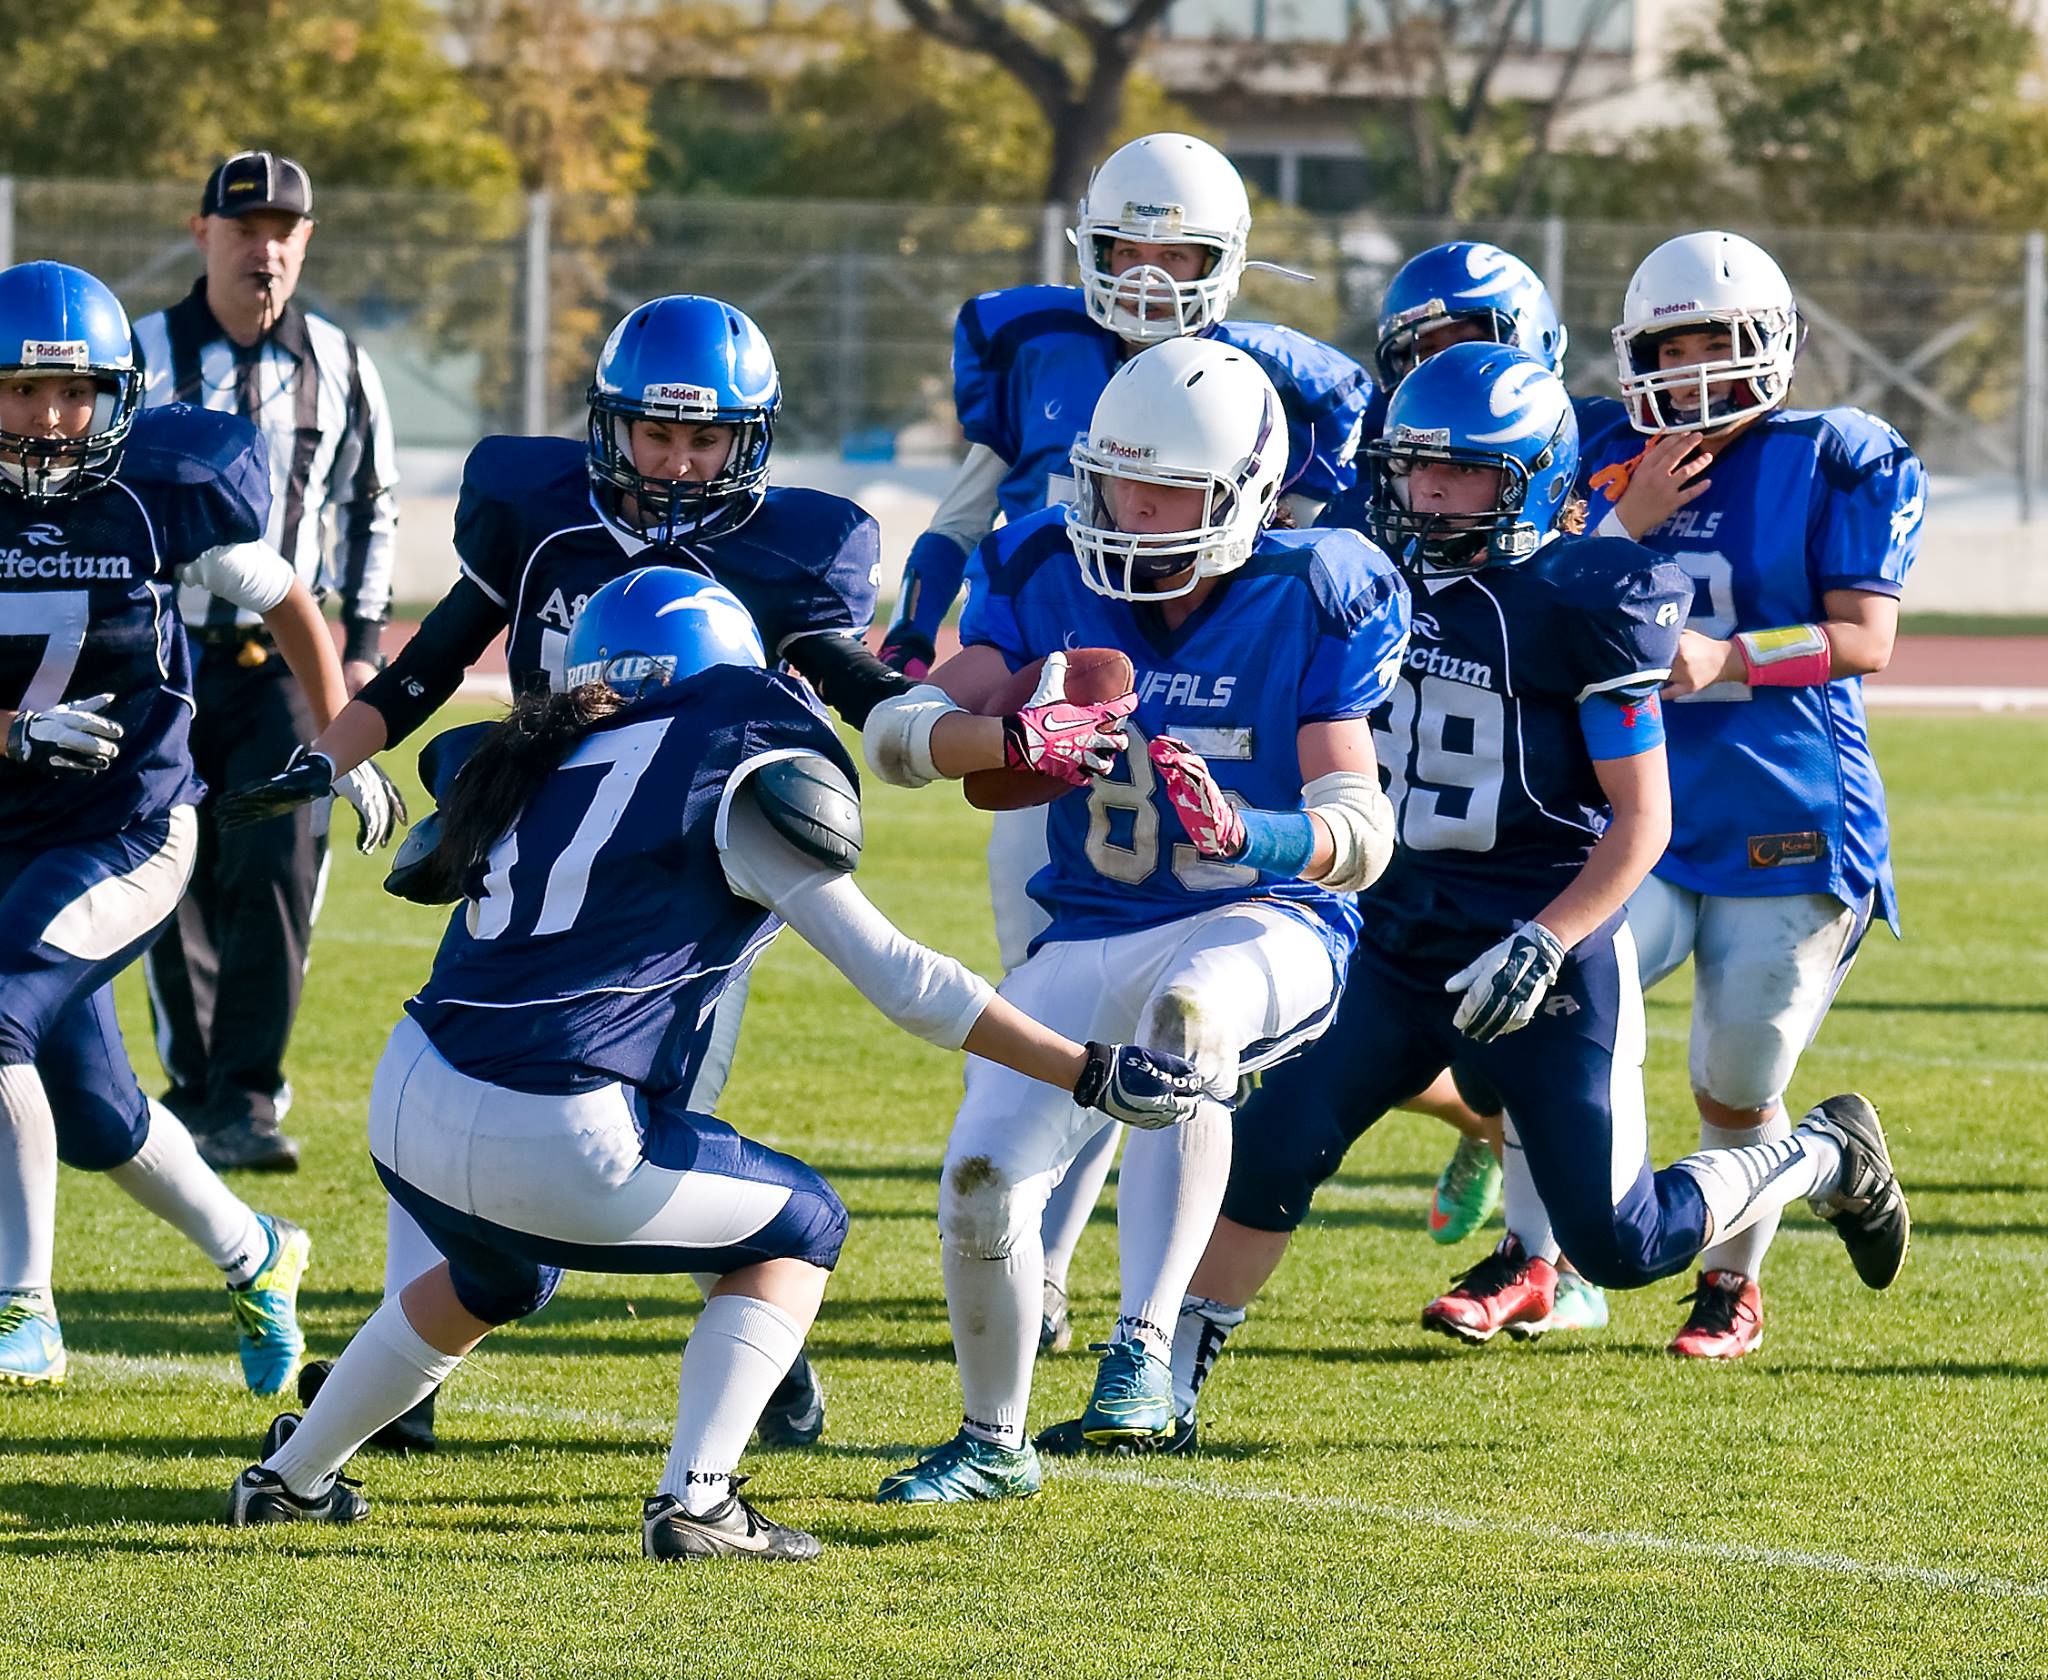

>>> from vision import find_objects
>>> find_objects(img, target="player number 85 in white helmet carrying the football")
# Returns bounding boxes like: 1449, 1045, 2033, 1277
864, 338, 1409, 1502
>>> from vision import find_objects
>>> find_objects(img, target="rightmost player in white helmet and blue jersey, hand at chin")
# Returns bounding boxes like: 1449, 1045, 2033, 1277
1585, 232, 1927, 1358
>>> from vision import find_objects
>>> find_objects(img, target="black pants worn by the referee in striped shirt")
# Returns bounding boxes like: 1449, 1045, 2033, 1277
145, 641, 328, 1135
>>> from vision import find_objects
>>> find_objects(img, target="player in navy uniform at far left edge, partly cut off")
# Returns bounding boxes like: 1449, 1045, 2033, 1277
0, 262, 403, 1393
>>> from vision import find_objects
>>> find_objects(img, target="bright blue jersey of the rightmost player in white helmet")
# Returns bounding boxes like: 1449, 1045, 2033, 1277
1579, 402, 1927, 930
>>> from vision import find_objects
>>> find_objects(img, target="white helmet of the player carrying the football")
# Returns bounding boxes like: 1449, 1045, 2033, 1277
1067, 338, 1288, 600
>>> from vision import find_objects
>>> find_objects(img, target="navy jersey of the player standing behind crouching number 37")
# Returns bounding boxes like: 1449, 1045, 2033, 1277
455, 436, 881, 690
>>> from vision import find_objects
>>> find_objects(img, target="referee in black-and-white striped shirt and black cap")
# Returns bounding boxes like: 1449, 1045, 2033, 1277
135, 152, 397, 1172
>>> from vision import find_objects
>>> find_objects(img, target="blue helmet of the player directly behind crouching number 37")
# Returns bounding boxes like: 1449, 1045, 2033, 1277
590, 295, 782, 543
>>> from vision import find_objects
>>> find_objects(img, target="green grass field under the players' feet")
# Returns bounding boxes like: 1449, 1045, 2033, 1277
0, 717, 2048, 1680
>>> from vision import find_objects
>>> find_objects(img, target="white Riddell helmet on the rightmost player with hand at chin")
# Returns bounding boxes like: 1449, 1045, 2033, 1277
1614, 234, 1802, 434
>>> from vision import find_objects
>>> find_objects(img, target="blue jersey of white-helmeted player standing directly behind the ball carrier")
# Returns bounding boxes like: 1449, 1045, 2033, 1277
952, 287, 1372, 520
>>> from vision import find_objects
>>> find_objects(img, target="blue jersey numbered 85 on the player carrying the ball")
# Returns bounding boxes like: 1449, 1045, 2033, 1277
961, 508, 1409, 967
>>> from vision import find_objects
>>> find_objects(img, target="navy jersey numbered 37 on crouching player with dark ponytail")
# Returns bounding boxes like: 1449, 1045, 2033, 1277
406, 666, 858, 1096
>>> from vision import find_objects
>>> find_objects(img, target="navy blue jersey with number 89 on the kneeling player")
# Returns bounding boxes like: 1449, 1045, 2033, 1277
1360, 537, 1690, 973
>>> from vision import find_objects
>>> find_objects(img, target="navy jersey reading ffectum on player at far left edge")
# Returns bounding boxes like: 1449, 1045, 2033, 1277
0, 404, 270, 846
